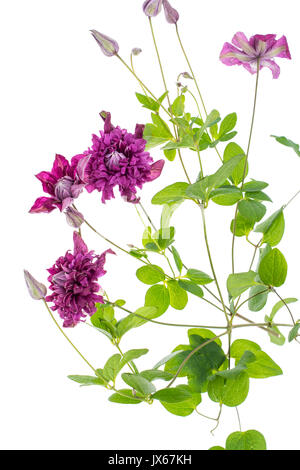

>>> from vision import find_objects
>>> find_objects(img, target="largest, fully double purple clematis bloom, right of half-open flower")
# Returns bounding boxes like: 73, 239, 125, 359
78, 112, 164, 203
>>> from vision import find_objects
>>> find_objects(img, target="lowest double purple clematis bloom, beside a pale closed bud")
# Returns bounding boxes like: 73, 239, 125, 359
45, 232, 115, 328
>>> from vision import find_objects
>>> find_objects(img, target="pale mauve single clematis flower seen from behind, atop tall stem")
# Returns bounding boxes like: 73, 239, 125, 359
220, 32, 291, 78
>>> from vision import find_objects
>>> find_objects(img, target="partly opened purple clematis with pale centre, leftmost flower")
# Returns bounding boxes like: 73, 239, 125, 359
29, 155, 84, 214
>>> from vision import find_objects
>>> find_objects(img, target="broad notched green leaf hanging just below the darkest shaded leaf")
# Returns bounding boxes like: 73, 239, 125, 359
207, 370, 249, 407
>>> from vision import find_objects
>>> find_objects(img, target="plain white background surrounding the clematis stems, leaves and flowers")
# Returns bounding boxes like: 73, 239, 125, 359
0, 0, 300, 450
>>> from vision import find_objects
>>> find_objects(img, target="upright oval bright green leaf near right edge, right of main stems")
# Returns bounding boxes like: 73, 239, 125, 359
258, 248, 287, 287
